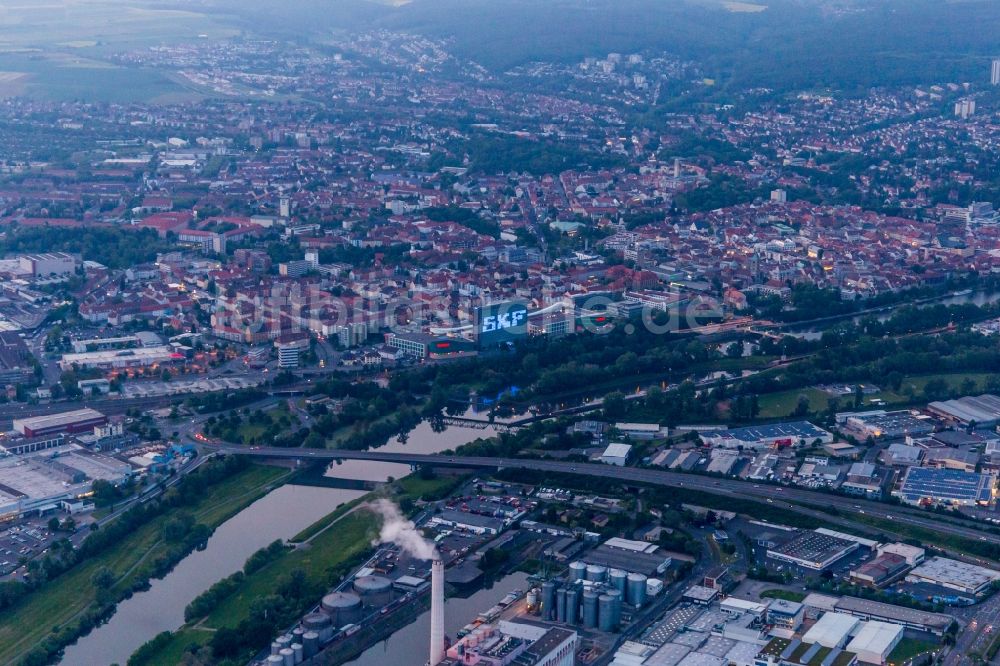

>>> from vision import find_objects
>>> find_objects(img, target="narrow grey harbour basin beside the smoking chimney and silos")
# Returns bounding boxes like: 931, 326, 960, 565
347, 573, 528, 666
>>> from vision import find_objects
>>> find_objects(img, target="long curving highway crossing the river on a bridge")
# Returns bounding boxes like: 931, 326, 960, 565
204, 446, 1000, 562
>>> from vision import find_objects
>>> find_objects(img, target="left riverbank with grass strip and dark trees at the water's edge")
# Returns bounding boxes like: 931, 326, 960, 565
0, 465, 290, 664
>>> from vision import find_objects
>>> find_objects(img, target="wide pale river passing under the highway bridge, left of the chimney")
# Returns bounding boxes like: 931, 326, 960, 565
60, 422, 496, 666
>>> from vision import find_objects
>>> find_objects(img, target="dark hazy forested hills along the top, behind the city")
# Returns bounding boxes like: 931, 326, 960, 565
219, 0, 1000, 89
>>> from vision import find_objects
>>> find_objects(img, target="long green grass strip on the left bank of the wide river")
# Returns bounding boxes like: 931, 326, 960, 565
0, 466, 288, 664
